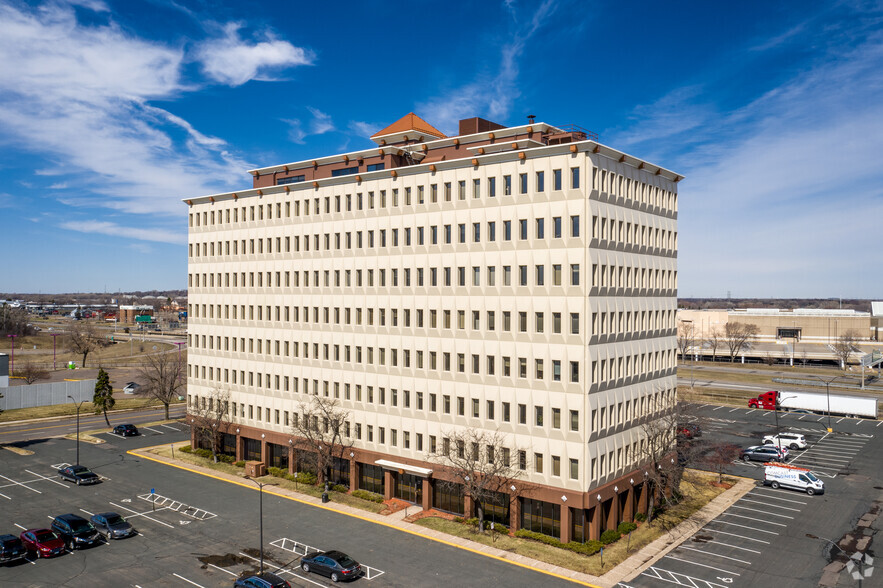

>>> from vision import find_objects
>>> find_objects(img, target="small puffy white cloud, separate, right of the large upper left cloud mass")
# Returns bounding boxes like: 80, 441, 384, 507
196, 23, 313, 86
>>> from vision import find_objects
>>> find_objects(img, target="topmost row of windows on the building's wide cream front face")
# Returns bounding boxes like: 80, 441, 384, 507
189, 167, 580, 227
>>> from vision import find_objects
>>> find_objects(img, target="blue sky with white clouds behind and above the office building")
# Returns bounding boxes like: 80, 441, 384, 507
0, 0, 883, 299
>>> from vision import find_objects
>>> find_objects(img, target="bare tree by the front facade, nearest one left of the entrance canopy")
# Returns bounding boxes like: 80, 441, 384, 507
291, 396, 355, 484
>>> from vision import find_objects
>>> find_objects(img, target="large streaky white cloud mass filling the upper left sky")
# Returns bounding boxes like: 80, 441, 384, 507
0, 0, 310, 223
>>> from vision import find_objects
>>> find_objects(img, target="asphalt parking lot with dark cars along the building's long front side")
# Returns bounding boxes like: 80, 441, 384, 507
0, 423, 572, 588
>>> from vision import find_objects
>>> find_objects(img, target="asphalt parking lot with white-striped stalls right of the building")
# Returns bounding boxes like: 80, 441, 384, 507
620, 405, 883, 588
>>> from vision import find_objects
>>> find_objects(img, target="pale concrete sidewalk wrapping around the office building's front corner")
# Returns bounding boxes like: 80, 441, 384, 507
135, 441, 755, 588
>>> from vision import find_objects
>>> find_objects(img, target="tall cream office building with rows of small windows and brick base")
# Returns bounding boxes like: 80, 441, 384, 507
186, 114, 682, 541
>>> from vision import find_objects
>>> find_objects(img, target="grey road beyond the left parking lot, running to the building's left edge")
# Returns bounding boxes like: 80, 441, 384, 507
0, 404, 186, 444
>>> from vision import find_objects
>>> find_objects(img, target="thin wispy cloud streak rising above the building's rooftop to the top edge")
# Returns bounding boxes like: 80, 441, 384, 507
417, 0, 558, 133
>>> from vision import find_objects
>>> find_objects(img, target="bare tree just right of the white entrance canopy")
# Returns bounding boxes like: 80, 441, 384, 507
430, 428, 528, 533
